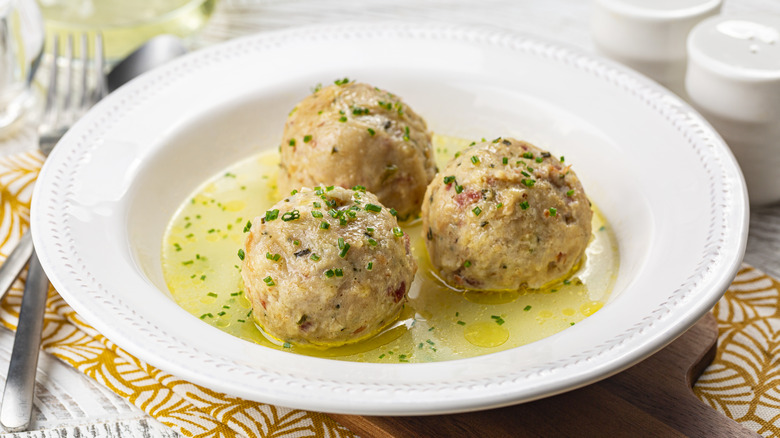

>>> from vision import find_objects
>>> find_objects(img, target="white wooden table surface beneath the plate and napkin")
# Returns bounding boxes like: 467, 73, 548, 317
0, 0, 780, 438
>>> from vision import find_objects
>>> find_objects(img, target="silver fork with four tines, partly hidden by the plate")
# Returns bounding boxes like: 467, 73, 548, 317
0, 34, 108, 432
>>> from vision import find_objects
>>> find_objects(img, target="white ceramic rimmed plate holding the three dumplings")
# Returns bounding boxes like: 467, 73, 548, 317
32, 24, 748, 415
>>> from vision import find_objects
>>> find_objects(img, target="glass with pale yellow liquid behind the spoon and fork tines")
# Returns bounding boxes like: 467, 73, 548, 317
38, 0, 216, 63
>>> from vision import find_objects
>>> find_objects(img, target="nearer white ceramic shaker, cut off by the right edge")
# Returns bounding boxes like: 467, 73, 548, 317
685, 13, 780, 206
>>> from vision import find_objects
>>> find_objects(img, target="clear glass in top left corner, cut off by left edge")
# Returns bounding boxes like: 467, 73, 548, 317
0, 0, 44, 137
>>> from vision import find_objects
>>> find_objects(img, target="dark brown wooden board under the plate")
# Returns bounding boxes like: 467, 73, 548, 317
330, 314, 758, 438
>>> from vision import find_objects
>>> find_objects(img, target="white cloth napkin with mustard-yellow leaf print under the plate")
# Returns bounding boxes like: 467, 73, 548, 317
0, 152, 780, 437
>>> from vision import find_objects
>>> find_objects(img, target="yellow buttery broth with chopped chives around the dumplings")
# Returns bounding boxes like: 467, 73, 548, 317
162, 136, 618, 363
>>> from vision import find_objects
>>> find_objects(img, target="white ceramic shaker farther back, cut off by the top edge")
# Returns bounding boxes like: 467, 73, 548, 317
590, 0, 722, 98
